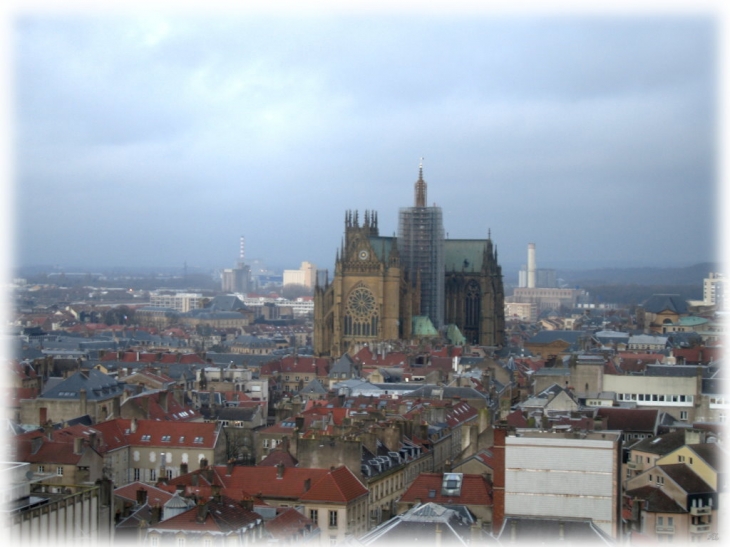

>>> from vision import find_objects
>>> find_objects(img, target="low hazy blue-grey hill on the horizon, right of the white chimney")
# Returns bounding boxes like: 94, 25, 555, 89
555, 262, 722, 288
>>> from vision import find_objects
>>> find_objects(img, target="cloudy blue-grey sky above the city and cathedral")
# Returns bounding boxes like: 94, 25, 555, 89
12, 8, 719, 270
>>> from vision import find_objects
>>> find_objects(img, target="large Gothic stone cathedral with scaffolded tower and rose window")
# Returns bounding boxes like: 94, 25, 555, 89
314, 167, 504, 357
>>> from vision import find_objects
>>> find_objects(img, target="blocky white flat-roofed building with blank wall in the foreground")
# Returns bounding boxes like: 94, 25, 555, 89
504, 429, 621, 539
